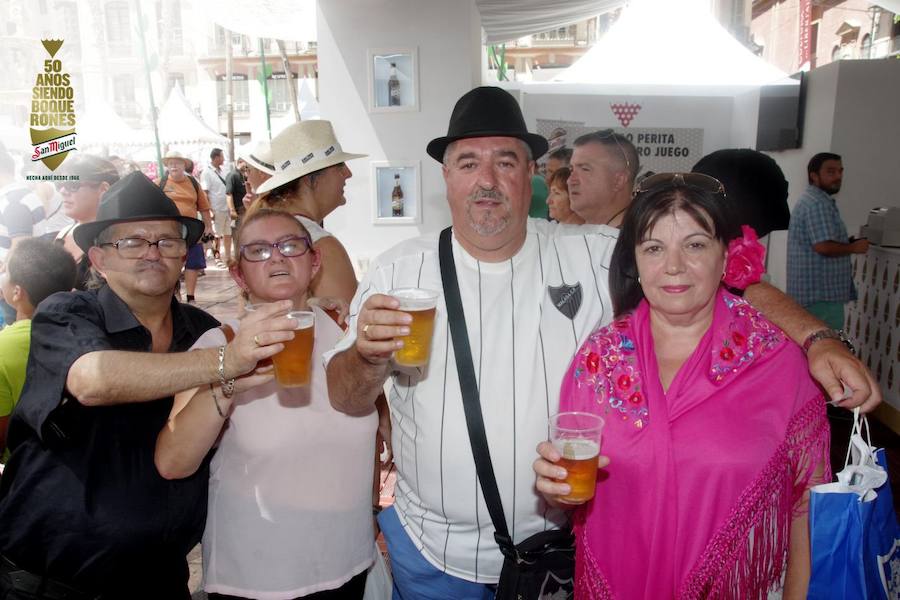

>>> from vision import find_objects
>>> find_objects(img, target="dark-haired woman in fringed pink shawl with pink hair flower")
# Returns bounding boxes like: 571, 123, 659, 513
535, 173, 830, 600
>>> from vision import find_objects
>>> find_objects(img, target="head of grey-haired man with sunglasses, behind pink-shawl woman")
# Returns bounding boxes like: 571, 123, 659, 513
568, 129, 640, 227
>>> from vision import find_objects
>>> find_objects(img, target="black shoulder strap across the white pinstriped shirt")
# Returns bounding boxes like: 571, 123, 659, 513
438, 227, 513, 551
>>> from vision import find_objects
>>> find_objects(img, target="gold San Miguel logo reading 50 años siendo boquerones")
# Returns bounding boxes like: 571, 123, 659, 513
29, 40, 75, 171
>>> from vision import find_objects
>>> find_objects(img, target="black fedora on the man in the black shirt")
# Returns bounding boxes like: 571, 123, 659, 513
72, 172, 203, 252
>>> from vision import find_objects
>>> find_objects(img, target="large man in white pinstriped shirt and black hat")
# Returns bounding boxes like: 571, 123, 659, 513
326, 87, 877, 600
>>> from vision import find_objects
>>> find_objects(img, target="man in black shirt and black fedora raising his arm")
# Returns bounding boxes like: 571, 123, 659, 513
0, 173, 292, 599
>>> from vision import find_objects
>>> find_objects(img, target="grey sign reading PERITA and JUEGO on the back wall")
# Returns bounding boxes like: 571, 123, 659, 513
537, 119, 703, 177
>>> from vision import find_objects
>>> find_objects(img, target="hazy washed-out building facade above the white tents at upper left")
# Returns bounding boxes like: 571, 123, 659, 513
0, 0, 317, 157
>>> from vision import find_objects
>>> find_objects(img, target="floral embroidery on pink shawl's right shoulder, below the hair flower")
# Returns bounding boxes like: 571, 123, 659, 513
709, 294, 784, 382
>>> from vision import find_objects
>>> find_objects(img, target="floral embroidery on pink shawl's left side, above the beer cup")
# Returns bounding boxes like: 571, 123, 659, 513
574, 315, 650, 429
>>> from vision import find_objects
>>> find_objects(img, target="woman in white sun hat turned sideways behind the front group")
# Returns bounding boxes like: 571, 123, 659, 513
251, 120, 366, 303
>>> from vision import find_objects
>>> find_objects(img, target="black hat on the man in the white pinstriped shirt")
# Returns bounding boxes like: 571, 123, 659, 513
426, 86, 549, 162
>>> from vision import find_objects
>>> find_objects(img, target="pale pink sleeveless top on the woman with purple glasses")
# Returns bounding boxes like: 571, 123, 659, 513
195, 308, 378, 600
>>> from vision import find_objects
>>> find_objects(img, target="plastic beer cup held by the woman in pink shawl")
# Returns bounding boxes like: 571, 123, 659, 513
550, 412, 605, 504
